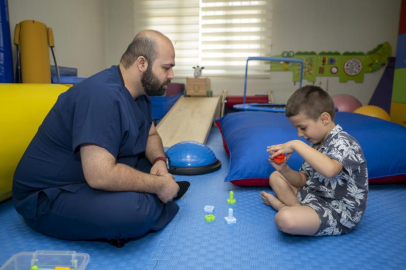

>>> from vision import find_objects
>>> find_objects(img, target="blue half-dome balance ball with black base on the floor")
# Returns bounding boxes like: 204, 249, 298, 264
166, 141, 221, 175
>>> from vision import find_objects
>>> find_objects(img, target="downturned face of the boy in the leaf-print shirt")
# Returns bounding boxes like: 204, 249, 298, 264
289, 113, 330, 144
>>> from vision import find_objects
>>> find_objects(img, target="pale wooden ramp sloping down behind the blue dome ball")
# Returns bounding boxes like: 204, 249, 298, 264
157, 96, 221, 147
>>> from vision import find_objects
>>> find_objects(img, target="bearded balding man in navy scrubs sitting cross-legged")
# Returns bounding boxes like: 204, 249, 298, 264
13, 30, 188, 246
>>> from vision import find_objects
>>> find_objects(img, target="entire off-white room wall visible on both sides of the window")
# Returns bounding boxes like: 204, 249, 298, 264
9, 0, 401, 104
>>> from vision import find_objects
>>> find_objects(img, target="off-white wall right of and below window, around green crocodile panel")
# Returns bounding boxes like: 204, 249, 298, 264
181, 0, 401, 105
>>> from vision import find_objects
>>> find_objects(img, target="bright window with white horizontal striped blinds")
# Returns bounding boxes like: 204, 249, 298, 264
134, 0, 273, 77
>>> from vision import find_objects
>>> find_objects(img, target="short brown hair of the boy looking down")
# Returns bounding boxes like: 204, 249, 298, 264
285, 85, 335, 121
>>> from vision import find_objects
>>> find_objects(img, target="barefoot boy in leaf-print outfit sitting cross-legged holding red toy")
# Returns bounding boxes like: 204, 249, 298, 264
261, 85, 368, 236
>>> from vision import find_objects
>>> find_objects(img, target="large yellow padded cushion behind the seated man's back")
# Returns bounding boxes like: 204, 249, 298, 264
0, 84, 69, 202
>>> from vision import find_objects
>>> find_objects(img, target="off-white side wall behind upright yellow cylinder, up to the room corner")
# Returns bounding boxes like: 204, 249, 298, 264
8, 0, 106, 77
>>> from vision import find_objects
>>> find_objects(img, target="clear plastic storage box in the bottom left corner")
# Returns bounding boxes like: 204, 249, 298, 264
0, 250, 90, 270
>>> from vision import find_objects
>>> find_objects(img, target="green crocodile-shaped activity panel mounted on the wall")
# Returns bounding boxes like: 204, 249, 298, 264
270, 42, 392, 83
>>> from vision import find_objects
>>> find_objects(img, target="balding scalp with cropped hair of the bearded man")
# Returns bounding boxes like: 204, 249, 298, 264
120, 30, 171, 69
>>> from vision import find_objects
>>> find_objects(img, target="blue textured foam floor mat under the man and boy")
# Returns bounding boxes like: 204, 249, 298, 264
0, 128, 406, 270
